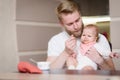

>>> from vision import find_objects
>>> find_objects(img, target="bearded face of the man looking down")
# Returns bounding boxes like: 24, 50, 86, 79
61, 11, 83, 37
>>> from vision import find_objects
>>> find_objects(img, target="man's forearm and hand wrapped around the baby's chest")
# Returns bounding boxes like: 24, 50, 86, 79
86, 47, 115, 70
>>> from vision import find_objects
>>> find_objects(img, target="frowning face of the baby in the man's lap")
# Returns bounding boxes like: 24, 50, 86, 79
81, 28, 97, 44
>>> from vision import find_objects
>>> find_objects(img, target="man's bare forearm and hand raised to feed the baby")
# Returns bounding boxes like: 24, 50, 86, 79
47, 36, 76, 69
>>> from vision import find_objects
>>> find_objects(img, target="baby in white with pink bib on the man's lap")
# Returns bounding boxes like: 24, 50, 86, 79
67, 24, 111, 70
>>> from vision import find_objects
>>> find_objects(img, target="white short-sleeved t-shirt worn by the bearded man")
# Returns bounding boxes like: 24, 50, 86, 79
47, 31, 110, 69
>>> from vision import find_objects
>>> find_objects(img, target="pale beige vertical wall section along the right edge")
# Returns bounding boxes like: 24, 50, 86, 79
110, 0, 120, 49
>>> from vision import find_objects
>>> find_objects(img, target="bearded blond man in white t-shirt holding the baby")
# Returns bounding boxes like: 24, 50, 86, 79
47, 0, 114, 70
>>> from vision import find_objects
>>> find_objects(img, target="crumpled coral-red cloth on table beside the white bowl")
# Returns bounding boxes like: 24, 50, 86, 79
18, 62, 42, 74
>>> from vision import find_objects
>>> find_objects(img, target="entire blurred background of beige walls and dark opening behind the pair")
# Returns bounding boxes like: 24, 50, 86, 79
0, 0, 120, 72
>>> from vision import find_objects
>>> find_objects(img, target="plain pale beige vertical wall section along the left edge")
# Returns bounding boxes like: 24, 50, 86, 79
0, 0, 18, 72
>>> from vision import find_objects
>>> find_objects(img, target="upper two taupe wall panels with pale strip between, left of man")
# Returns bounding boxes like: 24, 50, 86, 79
16, 0, 61, 52
